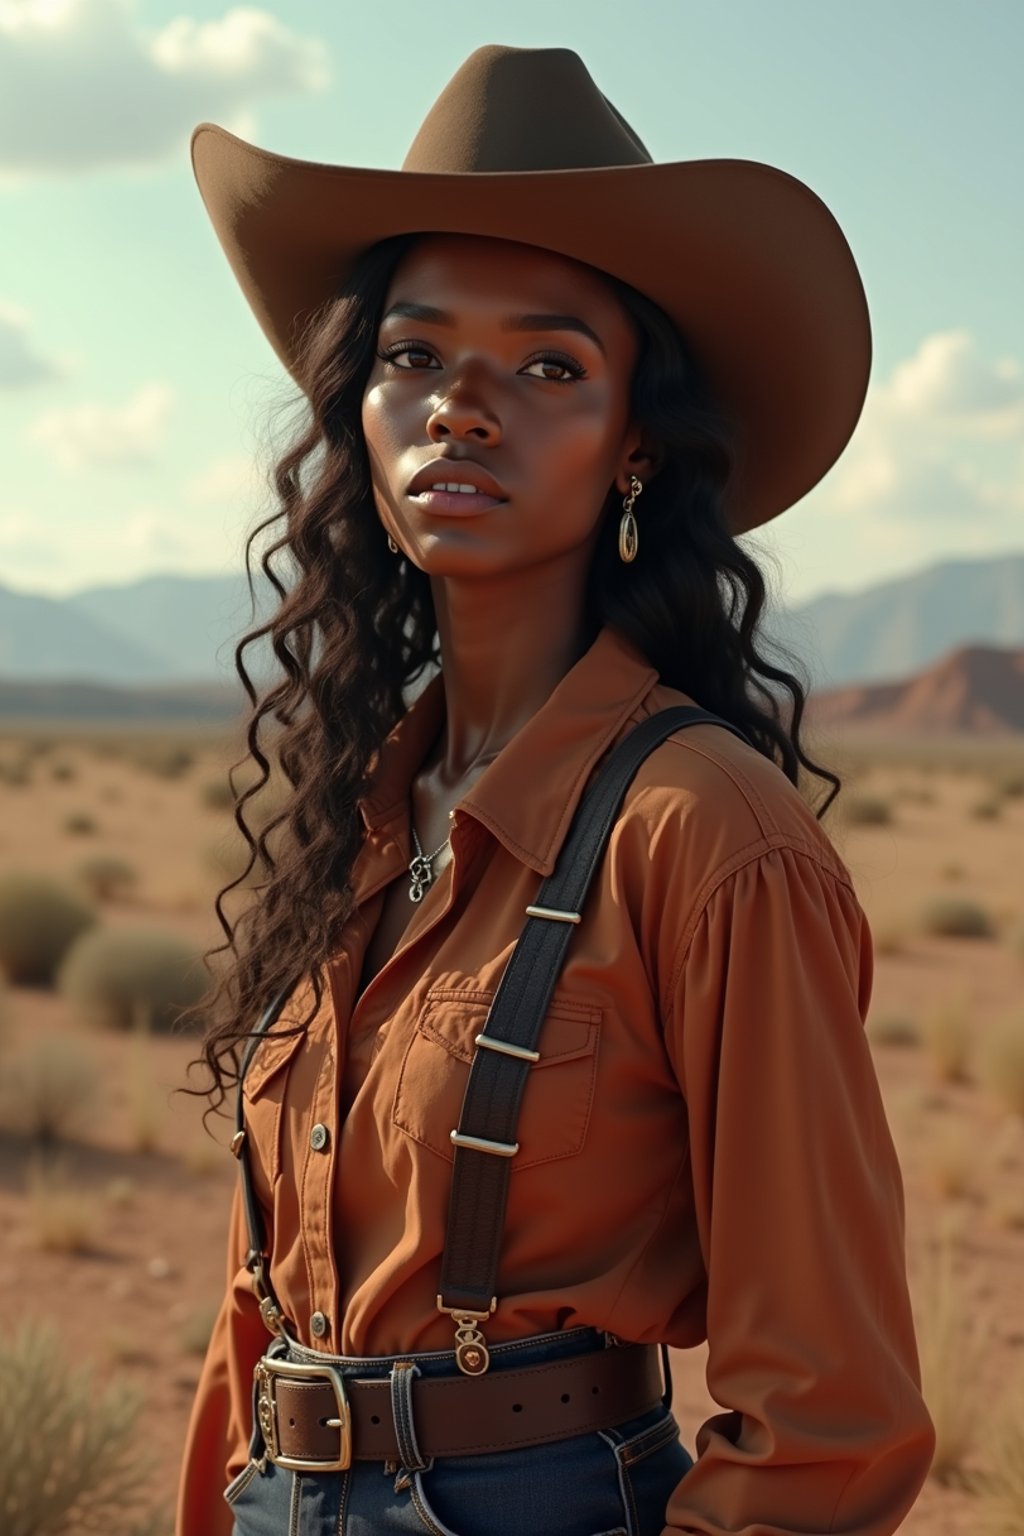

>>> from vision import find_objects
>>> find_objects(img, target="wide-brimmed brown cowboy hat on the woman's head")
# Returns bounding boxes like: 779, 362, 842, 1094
192, 45, 870, 533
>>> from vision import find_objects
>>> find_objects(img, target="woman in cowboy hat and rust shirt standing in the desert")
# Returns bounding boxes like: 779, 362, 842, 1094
178, 48, 933, 1536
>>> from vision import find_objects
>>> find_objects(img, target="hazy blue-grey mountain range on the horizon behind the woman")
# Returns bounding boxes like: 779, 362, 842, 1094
0, 551, 1024, 690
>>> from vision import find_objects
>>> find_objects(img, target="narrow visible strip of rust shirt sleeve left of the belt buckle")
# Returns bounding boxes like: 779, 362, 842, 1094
175, 1181, 270, 1536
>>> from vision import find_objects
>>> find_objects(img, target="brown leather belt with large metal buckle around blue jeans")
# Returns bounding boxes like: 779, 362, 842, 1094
256, 1344, 665, 1471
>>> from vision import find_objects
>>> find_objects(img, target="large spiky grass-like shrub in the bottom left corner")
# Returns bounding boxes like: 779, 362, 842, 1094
0, 1310, 167, 1536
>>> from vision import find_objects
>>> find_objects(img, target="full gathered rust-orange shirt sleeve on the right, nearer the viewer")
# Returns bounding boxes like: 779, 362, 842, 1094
663, 846, 935, 1536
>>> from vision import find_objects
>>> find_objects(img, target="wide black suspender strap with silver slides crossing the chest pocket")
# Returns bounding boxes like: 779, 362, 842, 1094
438, 705, 752, 1376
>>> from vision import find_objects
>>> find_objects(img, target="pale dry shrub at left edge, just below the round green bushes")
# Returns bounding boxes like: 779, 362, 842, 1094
0, 1038, 101, 1143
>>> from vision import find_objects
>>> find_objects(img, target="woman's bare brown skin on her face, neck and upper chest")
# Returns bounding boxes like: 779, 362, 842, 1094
362, 235, 654, 982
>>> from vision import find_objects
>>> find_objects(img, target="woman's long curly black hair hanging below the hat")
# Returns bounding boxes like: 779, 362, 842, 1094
183, 235, 841, 1114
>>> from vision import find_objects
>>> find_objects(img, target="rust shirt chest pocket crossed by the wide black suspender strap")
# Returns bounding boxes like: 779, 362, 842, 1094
393, 988, 602, 1177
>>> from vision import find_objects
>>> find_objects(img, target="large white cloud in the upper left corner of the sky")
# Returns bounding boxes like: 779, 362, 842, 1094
0, 0, 329, 181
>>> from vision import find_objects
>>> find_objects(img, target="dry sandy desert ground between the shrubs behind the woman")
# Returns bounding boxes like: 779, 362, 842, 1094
0, 730, 1024, 1536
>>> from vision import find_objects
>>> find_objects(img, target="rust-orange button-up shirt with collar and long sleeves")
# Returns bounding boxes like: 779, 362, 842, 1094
177, 627, 933, 1536
